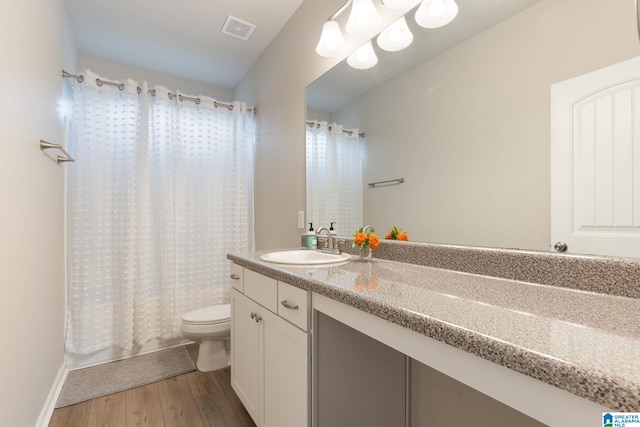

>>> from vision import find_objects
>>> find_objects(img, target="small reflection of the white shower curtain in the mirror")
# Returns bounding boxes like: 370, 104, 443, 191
306, 121, 364, 236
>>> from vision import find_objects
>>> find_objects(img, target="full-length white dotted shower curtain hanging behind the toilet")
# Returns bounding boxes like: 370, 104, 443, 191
66, 70, 255, 354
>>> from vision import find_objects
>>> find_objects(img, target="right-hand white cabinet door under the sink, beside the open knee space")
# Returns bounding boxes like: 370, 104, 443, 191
261, 310, 310, 427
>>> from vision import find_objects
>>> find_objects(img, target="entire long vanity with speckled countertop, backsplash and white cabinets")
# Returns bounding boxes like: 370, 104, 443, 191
228, 244, 640, 427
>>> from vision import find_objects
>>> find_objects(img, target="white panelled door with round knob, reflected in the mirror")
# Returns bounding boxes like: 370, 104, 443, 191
551, 57, 640, 258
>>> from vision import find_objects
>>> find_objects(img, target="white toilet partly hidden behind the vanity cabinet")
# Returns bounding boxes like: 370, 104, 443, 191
181, 304, 231, 372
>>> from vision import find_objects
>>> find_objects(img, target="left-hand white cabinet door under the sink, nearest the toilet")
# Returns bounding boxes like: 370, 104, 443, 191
231, 289, 262, 426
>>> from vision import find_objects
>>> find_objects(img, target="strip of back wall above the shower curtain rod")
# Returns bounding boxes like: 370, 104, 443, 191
74, 54, 234, 102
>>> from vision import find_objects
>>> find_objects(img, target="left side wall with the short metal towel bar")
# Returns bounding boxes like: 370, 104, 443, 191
0, 0, 76, 426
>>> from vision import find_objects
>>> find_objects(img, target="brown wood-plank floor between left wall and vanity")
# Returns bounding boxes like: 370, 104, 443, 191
49, 345, 255, 427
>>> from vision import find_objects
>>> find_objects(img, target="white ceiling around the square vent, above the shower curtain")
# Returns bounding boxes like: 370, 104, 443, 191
64, 0, 303, 89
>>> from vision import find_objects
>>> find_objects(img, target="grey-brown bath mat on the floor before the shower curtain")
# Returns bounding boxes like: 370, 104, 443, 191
56, 346, 196, 408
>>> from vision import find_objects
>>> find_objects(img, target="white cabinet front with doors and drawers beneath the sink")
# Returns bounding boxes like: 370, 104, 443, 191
231, 264, 310, 427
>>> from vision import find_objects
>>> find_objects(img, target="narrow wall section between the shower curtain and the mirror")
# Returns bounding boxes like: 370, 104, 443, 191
233, 0, 342, 249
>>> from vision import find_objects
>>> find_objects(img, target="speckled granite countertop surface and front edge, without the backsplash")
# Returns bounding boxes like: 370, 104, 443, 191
227, 253, 640, 412
